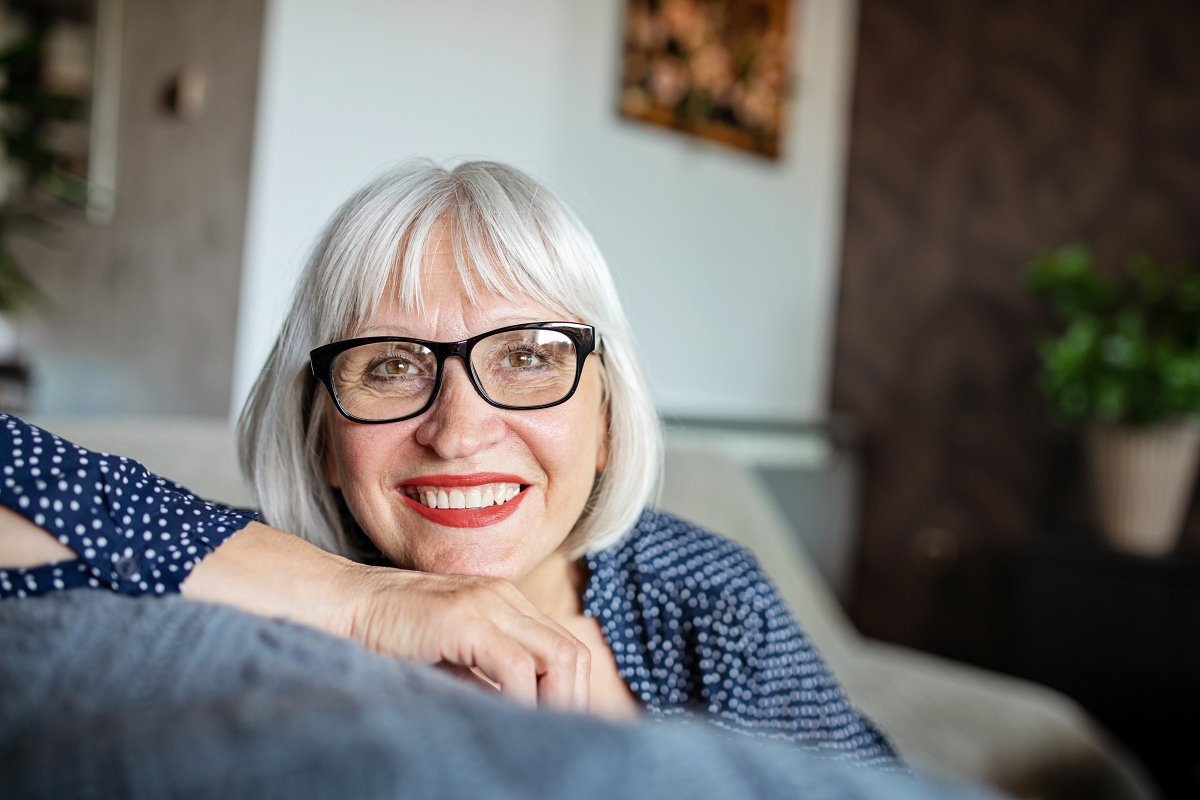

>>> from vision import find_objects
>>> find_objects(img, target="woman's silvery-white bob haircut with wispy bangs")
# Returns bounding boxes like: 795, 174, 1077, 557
238, 160, 662, 558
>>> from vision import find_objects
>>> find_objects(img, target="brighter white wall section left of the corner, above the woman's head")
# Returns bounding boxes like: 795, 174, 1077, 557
233, 0, 564, 414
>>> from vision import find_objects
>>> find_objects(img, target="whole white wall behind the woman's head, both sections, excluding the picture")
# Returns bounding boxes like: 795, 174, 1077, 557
233, 0, 854, 420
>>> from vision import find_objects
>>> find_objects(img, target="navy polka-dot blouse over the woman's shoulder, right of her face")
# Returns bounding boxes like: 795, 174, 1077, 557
583, 511, 901, 768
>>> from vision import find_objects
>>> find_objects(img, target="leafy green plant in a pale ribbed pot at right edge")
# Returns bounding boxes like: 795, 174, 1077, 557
1031, 245, 1200, 555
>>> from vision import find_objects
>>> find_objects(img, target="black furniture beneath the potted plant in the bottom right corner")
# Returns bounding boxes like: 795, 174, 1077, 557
1013, 535, 1200, 800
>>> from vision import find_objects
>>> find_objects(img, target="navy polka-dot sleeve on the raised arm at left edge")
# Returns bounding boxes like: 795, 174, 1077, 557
0, 414, 257, 599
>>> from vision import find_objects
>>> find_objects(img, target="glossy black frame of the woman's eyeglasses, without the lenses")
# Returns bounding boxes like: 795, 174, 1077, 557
308, 323, 600, 425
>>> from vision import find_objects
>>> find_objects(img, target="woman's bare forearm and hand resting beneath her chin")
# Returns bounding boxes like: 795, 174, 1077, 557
180, 522, 592, 711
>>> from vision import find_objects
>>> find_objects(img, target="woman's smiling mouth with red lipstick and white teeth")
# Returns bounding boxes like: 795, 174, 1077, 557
396, 473, 529, 528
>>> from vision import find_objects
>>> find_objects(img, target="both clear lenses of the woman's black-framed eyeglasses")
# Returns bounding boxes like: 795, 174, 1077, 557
334, 329, 578, 420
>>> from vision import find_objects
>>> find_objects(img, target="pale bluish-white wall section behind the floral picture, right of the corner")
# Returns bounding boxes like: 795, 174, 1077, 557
556, 0, 856, 420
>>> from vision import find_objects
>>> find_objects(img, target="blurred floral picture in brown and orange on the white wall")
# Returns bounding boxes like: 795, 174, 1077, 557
619, 0, 791, 158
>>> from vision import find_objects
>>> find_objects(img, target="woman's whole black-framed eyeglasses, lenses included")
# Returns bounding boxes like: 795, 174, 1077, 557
308, 323, 596, 423
